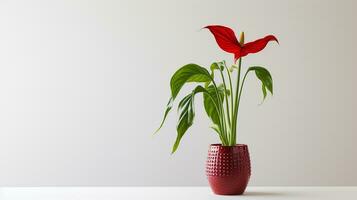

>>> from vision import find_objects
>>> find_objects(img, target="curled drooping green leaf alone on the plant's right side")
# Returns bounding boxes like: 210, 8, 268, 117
247, 66, 273, 101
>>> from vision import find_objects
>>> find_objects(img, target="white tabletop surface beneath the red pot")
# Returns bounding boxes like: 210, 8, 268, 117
0, 187, 357, 200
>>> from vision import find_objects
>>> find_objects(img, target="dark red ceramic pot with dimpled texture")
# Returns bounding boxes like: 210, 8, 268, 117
206, 144, 250, 195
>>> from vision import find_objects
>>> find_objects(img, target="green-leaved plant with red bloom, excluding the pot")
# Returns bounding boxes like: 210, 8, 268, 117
156, 25, 278, 153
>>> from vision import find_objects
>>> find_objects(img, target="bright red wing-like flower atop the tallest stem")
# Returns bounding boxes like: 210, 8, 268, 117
204, 25, 279, 62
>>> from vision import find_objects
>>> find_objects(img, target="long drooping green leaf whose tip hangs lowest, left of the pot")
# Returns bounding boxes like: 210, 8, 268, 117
171, 86, 206, 154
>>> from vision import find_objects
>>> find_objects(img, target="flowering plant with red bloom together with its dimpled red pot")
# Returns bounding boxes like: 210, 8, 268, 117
156, 25, 278, 195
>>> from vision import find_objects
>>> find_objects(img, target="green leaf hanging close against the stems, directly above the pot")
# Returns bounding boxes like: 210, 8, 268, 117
203, 85, 224, 133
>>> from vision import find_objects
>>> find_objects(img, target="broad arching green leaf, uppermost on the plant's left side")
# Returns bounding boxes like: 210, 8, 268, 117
170, 64, 212, 99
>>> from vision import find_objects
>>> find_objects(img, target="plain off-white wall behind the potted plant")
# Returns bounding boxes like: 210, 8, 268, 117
0, 0, 357, 186
